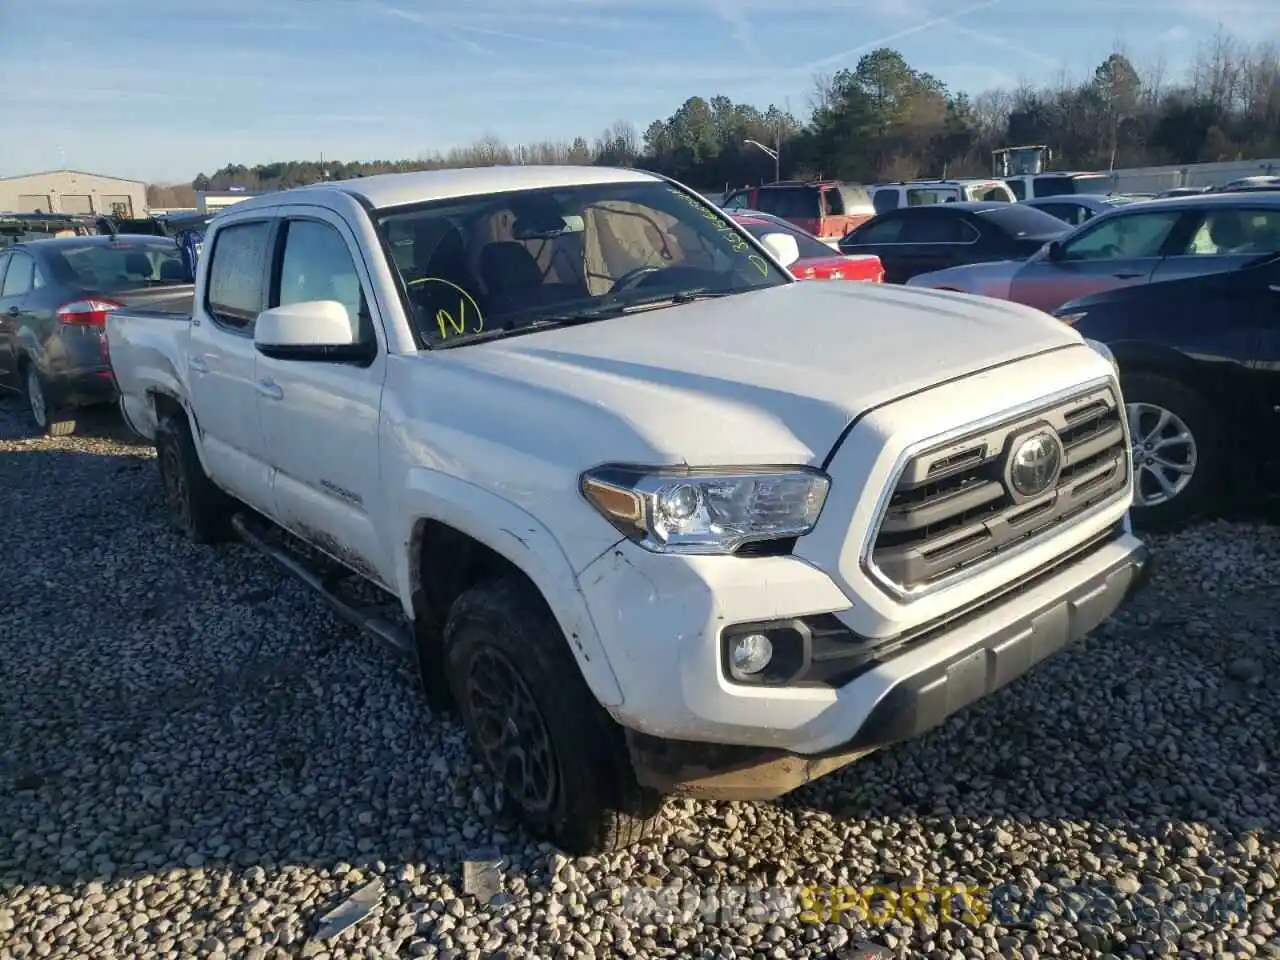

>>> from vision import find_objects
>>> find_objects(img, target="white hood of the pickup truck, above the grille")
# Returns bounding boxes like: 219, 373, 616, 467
420, 283, 1080, 466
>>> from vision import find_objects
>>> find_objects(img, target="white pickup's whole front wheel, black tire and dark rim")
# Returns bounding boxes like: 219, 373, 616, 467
444, 577, 662, 856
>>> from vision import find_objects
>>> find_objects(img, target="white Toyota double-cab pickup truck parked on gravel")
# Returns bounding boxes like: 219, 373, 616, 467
108, 166, 1149, 852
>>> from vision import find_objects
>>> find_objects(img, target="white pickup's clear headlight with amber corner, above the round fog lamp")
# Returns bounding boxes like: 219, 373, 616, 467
582, 466, 831, 554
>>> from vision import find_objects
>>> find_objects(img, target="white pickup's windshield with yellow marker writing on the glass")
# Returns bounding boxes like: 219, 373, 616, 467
376, 180, 791, 346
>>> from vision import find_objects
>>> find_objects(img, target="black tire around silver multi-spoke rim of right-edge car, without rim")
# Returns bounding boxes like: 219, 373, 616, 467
1120, 372, 1226, 530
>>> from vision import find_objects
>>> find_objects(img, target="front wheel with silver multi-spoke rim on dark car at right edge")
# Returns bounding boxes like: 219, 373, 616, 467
1120, 372, 1224, 530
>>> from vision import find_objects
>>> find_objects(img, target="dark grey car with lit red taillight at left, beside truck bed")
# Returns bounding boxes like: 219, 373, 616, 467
0, 236, 192, 435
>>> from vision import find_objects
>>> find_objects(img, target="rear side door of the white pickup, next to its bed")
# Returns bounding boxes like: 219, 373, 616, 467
187, 219, 275, 513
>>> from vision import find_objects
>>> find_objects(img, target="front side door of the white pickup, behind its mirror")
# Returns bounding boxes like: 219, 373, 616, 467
256, 205, 394, 585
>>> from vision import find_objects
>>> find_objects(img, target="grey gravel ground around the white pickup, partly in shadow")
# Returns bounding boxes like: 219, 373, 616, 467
0, 399, 1280, 960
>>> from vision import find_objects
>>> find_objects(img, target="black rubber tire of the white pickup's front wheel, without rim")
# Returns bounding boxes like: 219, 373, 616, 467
444, 576, 662, 856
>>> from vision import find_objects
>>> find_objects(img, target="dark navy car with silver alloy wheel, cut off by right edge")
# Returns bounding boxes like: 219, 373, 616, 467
1056, 250, 1280, 527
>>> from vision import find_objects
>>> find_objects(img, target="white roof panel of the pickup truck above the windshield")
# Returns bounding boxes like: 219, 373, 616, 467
262, 164, 658, 209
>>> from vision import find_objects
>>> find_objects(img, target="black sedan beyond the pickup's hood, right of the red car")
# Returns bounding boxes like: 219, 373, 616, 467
840, 201, 1069, 283
